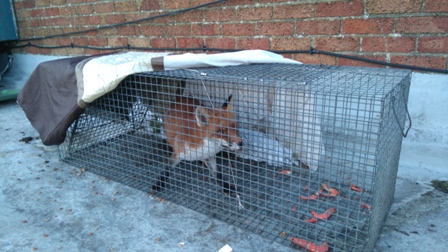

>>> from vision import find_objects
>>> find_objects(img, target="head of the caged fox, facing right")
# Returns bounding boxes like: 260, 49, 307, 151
195, 95, 242, 151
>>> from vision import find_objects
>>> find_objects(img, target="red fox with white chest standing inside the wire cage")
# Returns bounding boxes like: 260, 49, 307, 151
152, 95, 243, 191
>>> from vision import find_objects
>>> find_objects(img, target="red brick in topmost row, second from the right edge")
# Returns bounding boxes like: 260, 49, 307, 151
366, 0, 423, 14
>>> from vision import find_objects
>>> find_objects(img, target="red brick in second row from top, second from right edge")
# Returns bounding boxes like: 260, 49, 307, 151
342, 18, 394, 34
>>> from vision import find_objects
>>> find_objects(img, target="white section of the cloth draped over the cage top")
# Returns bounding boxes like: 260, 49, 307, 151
81, 50, 301, 103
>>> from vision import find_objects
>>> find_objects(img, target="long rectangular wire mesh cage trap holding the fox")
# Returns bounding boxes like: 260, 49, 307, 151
59, 64, 411, 251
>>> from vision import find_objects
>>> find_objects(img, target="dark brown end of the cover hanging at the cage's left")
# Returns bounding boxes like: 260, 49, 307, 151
17, 56, 96, 145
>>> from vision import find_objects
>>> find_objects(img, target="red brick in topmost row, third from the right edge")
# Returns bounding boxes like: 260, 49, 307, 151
316, 0, 364, 17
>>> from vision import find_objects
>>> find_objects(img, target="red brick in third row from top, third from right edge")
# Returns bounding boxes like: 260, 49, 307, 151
314, 36, 360, 52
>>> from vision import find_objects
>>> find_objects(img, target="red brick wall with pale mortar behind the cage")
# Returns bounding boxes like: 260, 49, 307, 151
9, 0, 448, 69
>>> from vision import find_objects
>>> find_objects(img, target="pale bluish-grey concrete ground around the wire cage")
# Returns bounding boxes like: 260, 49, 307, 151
0, 60, 448, 252
